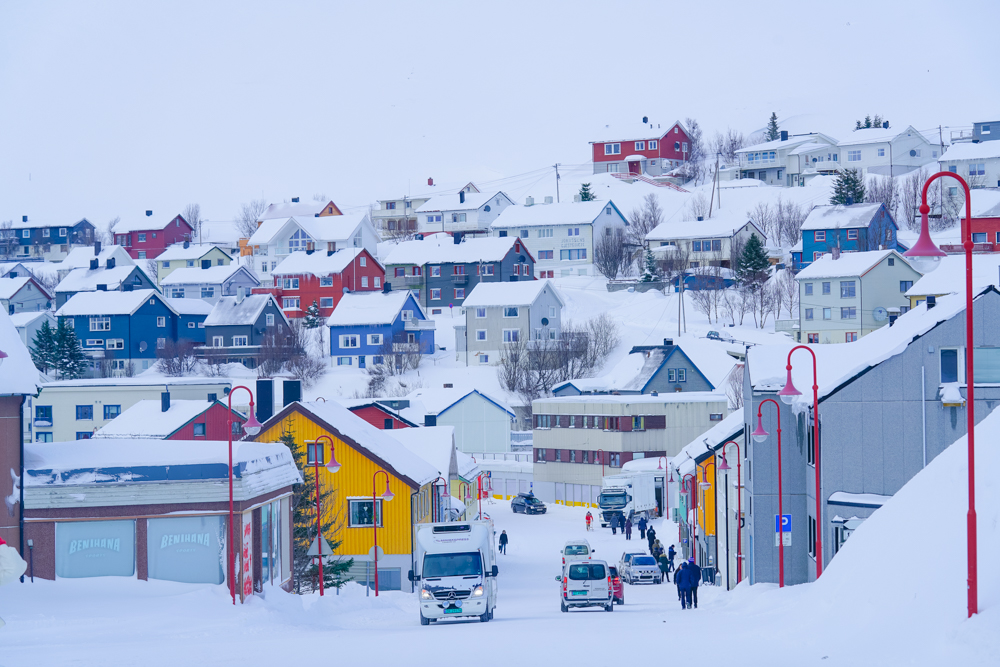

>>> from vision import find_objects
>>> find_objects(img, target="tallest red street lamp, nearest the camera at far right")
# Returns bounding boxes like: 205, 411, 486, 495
903, 171, 979, 617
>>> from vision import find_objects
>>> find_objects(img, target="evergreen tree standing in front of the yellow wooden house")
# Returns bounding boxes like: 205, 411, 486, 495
279, 419, 354, 592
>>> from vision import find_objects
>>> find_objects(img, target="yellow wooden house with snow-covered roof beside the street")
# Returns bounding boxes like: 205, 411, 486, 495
255, 401, 442, 590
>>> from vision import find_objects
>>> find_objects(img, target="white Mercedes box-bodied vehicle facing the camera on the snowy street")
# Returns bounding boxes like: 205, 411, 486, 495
409, 521, 497, 625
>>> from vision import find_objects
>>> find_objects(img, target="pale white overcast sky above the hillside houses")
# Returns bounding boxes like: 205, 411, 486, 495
0, 0, 1000, 230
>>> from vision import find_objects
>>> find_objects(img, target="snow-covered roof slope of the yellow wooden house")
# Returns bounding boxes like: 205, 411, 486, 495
282, 401, 438, 487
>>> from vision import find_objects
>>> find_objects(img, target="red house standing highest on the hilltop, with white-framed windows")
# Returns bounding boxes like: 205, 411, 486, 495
590, 117, 691, 176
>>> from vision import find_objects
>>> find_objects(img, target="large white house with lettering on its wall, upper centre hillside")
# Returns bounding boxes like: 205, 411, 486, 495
490, 197, 628, 278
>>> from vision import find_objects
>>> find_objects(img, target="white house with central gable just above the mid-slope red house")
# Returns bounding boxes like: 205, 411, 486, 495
247, 211, 379, 278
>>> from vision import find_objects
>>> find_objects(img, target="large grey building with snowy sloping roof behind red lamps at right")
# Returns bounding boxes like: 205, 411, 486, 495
744, 286, 1000, 584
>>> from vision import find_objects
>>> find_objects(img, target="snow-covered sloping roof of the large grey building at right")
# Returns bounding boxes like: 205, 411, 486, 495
747, 287, 998, 403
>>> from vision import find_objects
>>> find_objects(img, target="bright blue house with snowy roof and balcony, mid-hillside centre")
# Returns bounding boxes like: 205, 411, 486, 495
326, 283, 435, 368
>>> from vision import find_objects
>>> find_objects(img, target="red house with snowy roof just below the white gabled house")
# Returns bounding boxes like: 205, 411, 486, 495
253, 248, 385, 318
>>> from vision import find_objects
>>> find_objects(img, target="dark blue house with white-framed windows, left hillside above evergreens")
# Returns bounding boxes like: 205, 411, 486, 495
56, 290, 182, 373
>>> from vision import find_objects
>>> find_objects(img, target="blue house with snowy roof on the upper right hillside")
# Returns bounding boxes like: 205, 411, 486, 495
792, 203, 907, 271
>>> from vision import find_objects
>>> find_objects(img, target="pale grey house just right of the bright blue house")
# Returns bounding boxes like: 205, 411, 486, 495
455, 280, 566, 366
